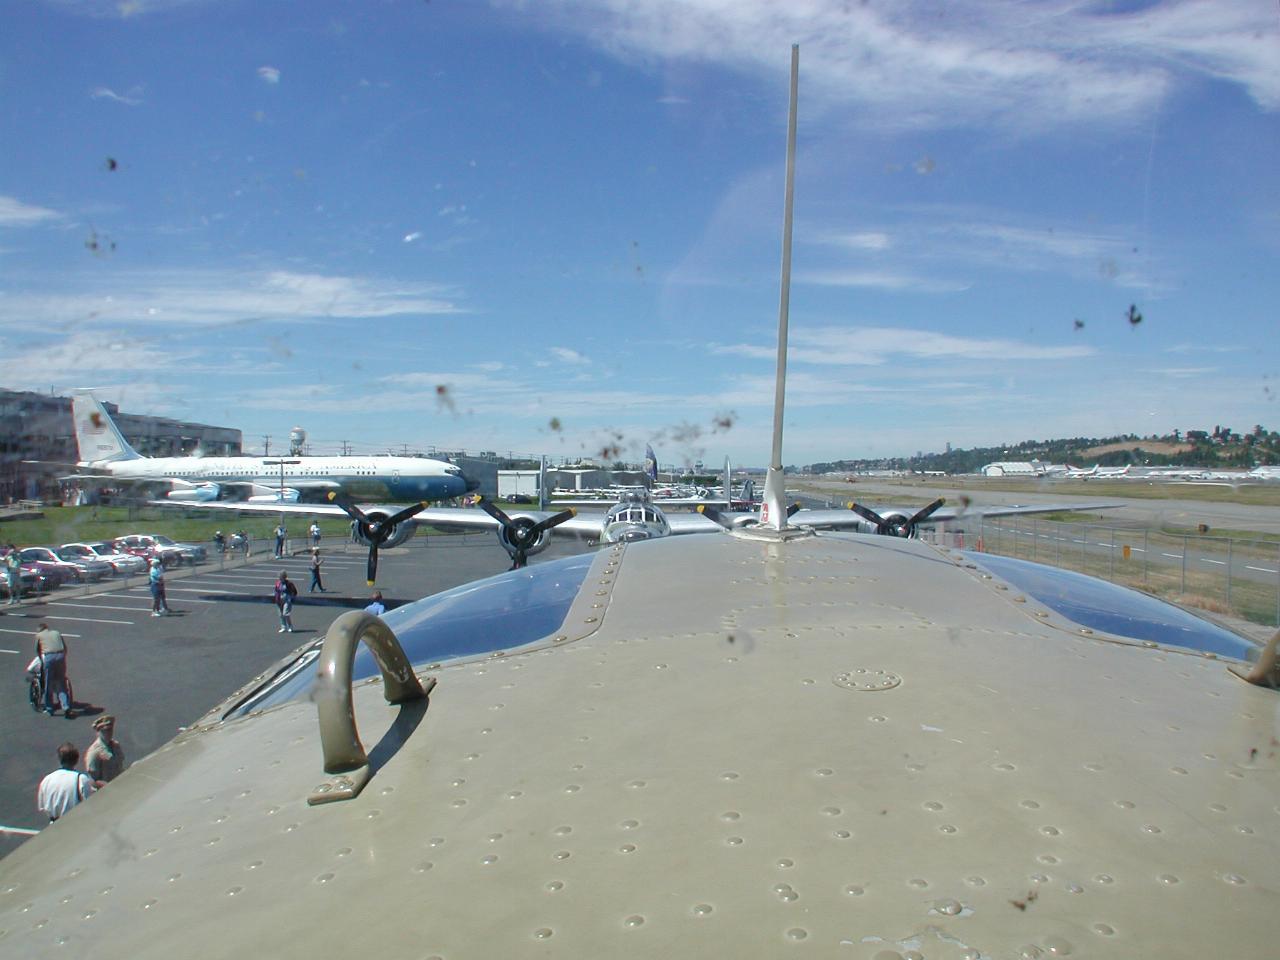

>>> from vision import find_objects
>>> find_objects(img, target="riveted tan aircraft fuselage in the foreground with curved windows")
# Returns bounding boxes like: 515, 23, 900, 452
0, 47, 1280, 960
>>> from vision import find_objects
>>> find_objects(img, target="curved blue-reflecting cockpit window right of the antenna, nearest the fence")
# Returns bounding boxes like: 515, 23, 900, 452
965, 552, 1257, 660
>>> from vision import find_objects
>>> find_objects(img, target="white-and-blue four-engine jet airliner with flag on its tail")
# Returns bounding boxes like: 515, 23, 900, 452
72, 394, 476, 507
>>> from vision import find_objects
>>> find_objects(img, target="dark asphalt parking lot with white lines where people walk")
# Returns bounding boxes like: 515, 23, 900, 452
0, 534, 589, 855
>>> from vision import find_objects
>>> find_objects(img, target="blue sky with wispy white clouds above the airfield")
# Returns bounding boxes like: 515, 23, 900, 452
0, 0, 1280, 465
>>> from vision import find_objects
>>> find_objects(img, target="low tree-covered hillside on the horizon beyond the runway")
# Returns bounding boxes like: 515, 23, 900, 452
787, 424, 1280, 474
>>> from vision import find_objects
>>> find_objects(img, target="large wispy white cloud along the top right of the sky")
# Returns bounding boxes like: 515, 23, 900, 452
522, 0, 1280, 129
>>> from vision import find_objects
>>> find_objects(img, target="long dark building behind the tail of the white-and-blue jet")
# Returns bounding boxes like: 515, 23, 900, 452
0, 389, 243, 503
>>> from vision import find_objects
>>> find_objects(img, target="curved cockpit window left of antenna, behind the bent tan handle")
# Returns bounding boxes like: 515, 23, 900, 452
224, 553, 595, 718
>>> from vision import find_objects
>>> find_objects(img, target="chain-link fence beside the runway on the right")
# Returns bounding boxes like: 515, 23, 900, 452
923, 516, 1280, 626
